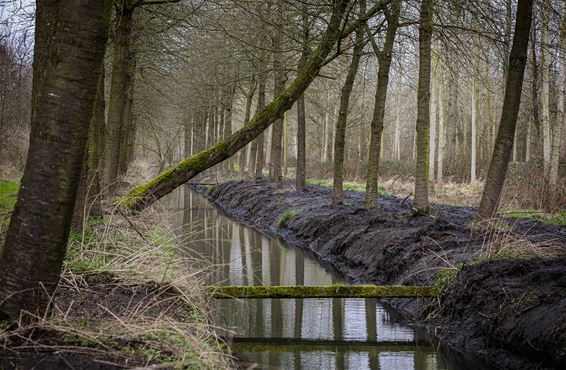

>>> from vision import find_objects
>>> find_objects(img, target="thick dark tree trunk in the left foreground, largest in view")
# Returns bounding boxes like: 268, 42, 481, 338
0, 0, 112, 321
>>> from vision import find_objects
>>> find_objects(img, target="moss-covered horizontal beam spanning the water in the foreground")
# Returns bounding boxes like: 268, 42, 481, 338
206, 285, 437, 299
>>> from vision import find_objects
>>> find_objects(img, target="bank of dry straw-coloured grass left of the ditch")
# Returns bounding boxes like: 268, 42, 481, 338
0, 183, 233, 370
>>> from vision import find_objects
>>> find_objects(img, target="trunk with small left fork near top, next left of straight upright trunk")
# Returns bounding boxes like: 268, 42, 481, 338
365, 0, 401, 208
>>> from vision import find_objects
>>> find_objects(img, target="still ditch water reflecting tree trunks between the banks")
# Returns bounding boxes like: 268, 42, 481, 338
169, 188, 492, 370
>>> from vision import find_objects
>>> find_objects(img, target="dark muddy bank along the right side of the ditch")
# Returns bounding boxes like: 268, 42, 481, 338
193, 180, 566, 369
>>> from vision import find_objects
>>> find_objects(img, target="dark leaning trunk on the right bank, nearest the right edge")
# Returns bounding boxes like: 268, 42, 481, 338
477, 0, 533, 219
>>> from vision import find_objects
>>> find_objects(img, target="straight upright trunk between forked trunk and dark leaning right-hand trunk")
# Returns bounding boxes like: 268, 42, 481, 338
413, 0, 433, 213
